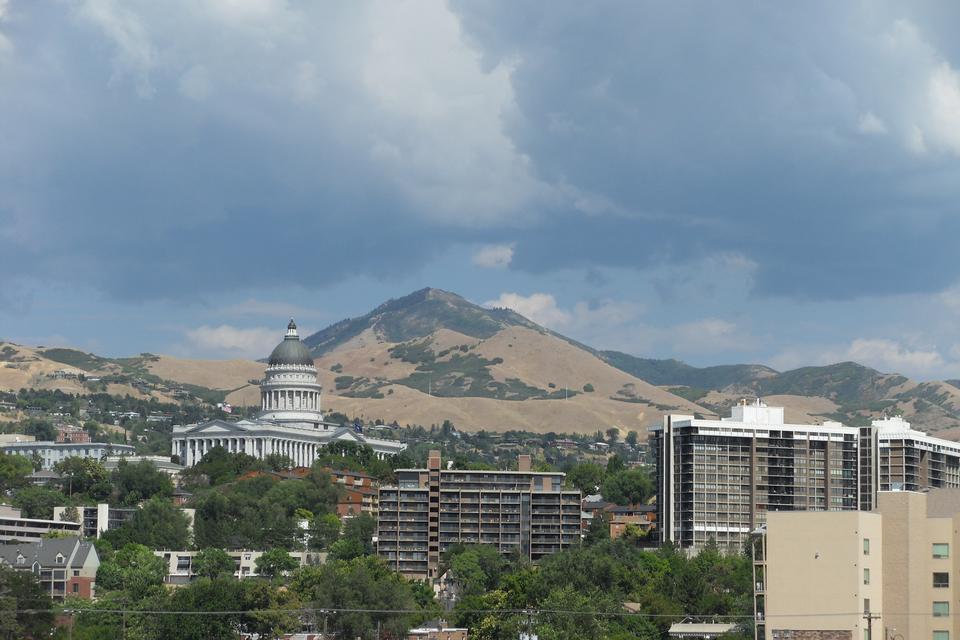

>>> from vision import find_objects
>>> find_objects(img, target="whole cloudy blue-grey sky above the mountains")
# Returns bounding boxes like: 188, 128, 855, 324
0, 0, 960, 380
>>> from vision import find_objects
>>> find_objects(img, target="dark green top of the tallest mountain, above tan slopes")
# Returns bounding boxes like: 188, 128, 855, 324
304, 287, 546, 355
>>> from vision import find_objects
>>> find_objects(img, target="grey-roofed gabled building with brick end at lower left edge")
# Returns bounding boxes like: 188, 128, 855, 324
0, 538, 100, 600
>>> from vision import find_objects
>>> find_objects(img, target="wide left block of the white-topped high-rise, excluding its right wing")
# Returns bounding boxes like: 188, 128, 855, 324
650, 401, 860, 549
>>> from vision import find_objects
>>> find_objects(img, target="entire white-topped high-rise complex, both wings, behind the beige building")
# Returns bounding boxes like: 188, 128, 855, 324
650, 400, 960, 550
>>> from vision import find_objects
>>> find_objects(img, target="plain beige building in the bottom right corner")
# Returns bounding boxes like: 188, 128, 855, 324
753, 489, 960, 640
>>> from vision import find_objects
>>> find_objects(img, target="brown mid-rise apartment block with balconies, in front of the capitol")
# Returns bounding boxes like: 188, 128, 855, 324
377, 451, 580, 580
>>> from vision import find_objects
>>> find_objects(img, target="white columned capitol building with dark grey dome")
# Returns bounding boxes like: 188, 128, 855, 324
172, 319, 407, 467
